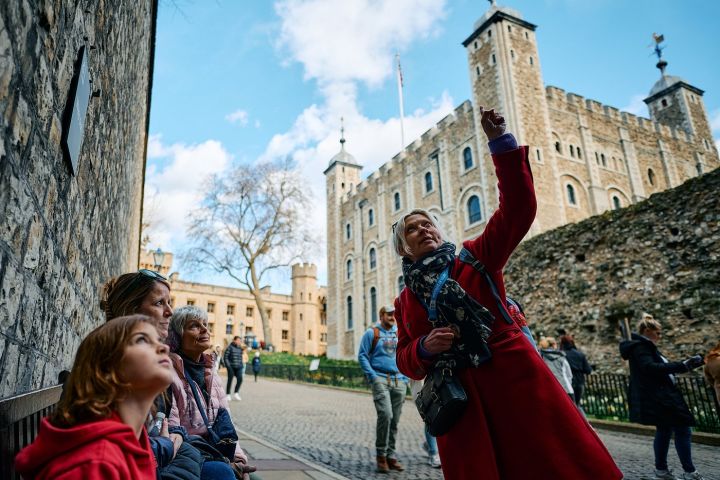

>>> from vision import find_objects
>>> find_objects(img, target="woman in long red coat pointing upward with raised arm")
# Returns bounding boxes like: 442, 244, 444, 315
393, 109, 623, 480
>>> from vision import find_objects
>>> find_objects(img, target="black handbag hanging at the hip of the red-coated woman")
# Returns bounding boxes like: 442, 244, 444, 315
415, 267, 468, 437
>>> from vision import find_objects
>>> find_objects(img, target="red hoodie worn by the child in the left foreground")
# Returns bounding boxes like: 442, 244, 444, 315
15, 416, 155, 480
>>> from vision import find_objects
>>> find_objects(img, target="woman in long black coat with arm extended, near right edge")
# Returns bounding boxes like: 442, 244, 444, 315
620, 315, 703, 479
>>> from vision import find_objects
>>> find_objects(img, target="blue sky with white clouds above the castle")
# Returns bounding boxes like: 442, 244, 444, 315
144, 0, 720, 293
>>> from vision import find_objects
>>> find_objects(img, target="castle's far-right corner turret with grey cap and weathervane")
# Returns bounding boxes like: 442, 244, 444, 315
644, 54, 717, 177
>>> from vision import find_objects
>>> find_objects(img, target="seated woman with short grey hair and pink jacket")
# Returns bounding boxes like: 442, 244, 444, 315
167, 305, 255, 475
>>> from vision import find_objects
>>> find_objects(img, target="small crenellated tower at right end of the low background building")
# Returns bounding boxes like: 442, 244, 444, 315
290, 263, 320, 354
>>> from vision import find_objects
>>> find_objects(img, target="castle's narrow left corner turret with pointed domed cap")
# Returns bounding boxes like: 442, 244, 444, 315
323, 128, 362, 358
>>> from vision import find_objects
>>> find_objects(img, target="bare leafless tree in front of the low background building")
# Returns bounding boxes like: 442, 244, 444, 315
183, 162, 314, 344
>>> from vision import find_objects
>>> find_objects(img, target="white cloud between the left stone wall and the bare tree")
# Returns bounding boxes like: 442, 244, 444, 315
144, 139, 232, 255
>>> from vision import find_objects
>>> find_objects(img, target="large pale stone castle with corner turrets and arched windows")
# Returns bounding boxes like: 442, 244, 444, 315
325, 6, 720, 358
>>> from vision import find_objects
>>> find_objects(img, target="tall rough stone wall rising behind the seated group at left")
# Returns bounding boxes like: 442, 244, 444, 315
0, 0, 155, 398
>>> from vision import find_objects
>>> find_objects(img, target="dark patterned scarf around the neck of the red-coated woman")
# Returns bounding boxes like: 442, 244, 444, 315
403, 242, 494, 367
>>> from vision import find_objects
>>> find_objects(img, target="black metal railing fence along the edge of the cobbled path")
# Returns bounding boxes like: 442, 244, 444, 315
261, 365, 720, 433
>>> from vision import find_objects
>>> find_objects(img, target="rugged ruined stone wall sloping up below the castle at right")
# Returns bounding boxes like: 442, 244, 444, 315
505, 170, 720, 371
